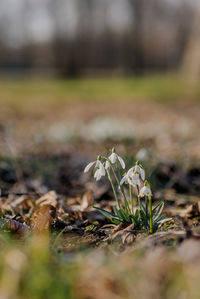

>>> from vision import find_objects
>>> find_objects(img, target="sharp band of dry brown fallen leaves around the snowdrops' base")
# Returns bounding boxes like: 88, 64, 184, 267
0, 154, 200, 249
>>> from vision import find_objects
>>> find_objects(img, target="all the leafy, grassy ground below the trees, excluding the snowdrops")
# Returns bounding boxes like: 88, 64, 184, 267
0, 76, 200, 299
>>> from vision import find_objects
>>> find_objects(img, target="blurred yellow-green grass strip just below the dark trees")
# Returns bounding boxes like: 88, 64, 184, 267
0, 74, 200, 109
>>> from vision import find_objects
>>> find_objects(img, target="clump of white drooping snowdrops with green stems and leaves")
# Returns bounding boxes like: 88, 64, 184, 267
84, 148, 166, 234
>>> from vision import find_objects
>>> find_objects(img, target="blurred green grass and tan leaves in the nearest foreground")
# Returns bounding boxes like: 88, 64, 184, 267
0, 237, 200, 299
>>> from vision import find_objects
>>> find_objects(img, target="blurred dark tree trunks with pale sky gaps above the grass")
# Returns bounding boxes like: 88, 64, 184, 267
0, 0, 200, 77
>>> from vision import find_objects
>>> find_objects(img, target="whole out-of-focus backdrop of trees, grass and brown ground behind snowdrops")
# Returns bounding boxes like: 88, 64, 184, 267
0, 0, 200, 197
